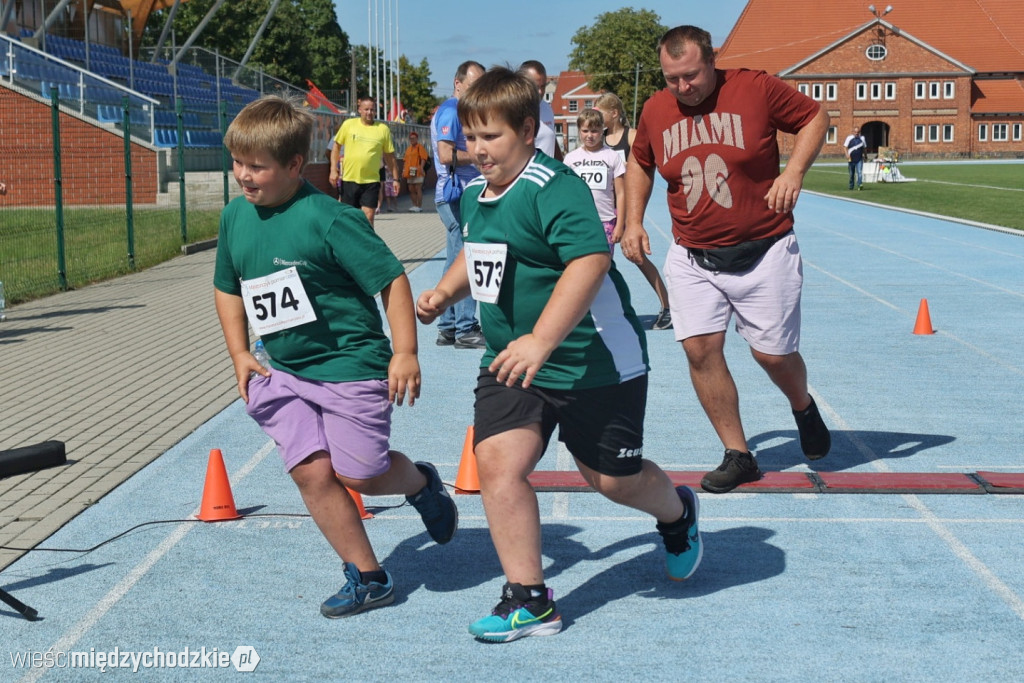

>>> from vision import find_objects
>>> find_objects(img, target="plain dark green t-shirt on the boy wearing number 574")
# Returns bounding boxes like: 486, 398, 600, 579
213, 182, 404, 382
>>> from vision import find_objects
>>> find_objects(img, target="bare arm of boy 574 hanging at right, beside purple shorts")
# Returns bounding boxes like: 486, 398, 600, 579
381, 272, 420, 405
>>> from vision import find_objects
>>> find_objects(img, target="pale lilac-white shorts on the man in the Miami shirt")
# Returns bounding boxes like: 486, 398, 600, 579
665, 232, 804, 355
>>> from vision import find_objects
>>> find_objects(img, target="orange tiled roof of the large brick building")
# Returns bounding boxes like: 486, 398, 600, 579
717, 0, 1024, 74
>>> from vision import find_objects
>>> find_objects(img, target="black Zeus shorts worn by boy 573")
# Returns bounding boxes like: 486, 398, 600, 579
473, 368, 647, 476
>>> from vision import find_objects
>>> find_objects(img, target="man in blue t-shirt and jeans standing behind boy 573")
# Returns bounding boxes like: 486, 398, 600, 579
430, 60, 485, 349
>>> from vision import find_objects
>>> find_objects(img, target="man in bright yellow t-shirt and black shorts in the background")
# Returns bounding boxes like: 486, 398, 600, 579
330, 97, 398, 225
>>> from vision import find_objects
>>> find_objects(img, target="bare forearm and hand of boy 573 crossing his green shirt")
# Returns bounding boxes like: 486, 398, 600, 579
488, 252, 611, 387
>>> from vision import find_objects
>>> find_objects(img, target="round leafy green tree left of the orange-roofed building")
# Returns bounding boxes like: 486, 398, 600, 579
569, 7, 669, 125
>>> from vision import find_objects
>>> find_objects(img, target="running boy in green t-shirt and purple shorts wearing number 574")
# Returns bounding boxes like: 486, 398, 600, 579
214, 96, 458, 617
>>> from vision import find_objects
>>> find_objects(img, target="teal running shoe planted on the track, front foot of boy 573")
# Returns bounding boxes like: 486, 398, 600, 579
469, 584, 562, 643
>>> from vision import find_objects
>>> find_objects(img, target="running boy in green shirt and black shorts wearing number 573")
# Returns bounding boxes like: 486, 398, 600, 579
417, 68, 701, 642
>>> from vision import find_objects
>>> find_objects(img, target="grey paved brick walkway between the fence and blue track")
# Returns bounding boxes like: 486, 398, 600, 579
0, 200, 444, 569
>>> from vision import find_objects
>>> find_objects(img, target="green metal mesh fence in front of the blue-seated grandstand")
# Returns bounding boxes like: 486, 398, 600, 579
0, 36, 429, 305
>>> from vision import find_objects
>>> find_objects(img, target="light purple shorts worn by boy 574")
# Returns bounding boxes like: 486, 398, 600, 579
246, 370, 392, 479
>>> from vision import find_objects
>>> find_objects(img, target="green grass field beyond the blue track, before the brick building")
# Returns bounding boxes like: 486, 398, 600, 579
804, 163, 1024, 230
